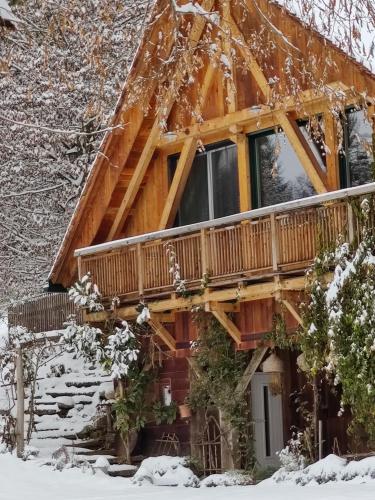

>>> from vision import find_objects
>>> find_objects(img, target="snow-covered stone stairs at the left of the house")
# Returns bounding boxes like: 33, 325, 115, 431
25, 351, 117, 464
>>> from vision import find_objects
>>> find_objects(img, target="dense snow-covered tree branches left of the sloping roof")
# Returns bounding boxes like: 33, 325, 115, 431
0, 0, 152, 302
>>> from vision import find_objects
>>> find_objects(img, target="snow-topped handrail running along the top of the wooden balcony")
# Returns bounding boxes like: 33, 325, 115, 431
74, 182, 375, 257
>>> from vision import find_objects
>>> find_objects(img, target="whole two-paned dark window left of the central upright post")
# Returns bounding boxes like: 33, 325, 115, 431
169, 143, 239, 226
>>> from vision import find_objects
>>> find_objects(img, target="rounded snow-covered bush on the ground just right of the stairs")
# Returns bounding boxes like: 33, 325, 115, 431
132, 456, 199, 488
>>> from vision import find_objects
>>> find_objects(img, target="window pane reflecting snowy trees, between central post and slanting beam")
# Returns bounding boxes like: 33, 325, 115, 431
251, 132, 315, 207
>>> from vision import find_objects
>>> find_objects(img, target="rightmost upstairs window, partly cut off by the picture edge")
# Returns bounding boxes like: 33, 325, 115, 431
340, 110, 374, 188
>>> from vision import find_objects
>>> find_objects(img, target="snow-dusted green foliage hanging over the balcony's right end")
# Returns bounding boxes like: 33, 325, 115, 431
300, 200, 375, 440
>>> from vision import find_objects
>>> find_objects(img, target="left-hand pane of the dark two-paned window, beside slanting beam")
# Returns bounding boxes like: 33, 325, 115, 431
178, 154, 209, 226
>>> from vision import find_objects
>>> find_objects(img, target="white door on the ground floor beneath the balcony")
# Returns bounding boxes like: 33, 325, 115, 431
251, 373, 284, 467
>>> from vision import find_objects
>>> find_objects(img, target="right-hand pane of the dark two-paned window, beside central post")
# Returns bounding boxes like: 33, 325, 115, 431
211, 146, 239, 218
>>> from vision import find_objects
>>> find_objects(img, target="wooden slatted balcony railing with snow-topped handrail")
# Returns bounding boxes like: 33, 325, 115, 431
75, 183, 375, 299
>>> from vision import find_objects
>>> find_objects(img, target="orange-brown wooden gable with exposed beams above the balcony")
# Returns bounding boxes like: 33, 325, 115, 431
50, 0, 375, 286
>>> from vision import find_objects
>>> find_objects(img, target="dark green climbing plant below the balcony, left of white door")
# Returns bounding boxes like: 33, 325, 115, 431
188, 313, 254, 468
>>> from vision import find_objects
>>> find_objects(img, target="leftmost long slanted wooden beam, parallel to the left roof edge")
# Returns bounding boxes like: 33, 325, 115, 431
107, 0, 214, 241
